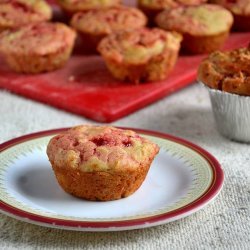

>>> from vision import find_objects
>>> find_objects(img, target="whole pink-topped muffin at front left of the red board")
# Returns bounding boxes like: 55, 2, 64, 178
0, 23, 76, 73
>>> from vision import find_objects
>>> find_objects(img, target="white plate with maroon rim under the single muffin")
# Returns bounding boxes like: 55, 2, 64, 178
0, 129, 223, 231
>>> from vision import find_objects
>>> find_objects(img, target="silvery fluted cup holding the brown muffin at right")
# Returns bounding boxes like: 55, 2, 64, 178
202, 83, 250, 143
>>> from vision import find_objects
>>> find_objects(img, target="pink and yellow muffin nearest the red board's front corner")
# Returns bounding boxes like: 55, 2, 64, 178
98, 28, 182, 83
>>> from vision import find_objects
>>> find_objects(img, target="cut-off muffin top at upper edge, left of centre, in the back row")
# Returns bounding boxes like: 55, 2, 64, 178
57, 0, 121, 13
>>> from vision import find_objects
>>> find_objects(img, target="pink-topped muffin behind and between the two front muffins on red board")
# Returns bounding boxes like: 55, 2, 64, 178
70, 6, 147, 54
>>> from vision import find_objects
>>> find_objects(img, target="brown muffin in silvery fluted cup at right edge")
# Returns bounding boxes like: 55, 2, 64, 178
198, 47, 250, 142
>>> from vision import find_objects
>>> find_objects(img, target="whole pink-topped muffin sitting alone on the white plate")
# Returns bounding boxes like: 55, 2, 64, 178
47, 125, 159, 201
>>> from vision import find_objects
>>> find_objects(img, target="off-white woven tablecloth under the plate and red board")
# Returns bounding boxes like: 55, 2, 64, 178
0, 84, 250, 249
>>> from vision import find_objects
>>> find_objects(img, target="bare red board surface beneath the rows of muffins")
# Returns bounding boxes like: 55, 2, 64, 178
0, 33, 250, 122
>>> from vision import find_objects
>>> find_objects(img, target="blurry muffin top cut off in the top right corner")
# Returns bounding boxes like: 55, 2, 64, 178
212, 0, 250, 16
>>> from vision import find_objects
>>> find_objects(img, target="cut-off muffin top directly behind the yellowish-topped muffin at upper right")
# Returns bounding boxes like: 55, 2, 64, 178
138, 0, 207, 10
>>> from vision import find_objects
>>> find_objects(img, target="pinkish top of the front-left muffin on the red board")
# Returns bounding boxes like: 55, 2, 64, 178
0, 23, 76, 55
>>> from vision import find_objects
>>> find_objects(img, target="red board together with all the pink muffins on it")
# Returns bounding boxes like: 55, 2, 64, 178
0, 0, 250, 122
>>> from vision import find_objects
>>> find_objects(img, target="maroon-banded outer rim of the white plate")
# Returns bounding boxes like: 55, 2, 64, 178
0, 127, 224, 231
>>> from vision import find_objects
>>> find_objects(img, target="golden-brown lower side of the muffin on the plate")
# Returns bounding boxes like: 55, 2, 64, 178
52, 162, 151, 201
